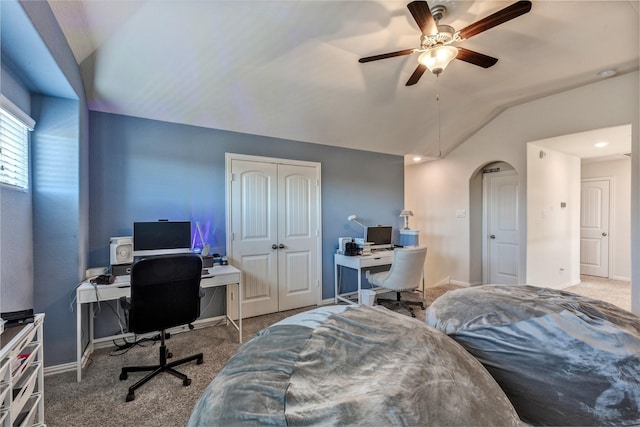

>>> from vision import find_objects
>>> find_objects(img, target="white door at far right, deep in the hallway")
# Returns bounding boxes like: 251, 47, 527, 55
580, 180, 610, 277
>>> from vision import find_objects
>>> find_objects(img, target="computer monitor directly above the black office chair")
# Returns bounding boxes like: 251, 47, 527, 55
133, 221, 191, 257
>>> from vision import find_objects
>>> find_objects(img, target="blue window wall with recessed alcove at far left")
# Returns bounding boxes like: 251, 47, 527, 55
0, 0, 89, 366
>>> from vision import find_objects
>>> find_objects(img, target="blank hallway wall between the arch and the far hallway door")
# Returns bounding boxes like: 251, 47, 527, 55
525, 143, 580, 289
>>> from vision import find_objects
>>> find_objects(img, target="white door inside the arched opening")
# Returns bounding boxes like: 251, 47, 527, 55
484, 172, 520, 284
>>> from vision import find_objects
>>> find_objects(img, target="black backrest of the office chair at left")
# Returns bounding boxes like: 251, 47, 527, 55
129, 254, 202, 334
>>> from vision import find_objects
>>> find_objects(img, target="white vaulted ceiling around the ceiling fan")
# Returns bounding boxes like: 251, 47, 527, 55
49, 0, 640, 162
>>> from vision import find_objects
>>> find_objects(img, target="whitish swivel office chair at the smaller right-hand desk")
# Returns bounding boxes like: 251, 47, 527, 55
366, 246, 427, 317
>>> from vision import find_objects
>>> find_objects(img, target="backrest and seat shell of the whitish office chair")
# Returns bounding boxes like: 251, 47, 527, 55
376, 246, 427, 291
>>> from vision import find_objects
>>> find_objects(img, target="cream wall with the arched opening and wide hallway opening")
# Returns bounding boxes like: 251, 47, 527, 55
405, 71, 640, 311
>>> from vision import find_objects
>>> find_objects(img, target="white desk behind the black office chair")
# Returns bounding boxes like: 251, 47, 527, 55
76, 265, 242, 382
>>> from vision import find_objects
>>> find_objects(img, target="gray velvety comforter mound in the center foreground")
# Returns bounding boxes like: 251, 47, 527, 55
188, 306, 519, 426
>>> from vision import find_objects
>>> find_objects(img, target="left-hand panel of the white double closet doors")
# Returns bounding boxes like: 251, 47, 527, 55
231, 160, 278, 317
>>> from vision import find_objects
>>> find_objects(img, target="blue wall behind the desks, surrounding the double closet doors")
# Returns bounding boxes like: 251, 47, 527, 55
89, 112, 404, 333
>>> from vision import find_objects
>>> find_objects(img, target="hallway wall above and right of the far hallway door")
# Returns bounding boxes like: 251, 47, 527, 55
582, 158, 631, 281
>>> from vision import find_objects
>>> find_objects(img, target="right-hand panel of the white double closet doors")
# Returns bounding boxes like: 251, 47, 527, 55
278, 165, 319, 311
